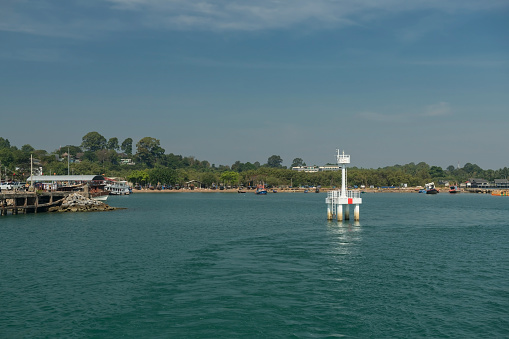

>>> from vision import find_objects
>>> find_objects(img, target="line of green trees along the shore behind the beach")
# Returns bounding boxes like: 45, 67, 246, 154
0, 132, 509, 187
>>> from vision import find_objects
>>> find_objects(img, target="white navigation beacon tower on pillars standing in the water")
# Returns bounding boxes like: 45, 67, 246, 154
325, 149, 362, 221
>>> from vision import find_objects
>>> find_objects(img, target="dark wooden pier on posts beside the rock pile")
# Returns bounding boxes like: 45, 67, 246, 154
0, 192, 69, 216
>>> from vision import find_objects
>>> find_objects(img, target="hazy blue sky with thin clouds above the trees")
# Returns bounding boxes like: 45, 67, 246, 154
0, 0, 509, 169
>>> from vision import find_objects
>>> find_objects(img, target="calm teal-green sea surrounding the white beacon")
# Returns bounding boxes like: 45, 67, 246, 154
0, 192, 509, 338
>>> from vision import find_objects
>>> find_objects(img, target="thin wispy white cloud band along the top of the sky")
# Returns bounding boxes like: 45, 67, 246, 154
0, 0, 507, 36
